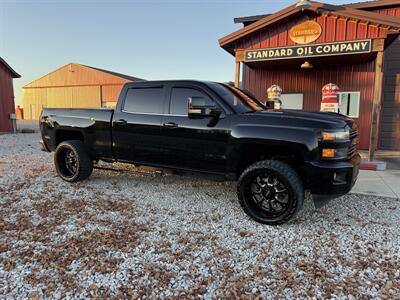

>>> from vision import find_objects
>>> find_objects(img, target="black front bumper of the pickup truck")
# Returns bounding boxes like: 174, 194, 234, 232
304, 154, 361, 206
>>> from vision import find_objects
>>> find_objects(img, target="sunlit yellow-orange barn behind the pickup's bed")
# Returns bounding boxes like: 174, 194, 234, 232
22, 63, 143, 120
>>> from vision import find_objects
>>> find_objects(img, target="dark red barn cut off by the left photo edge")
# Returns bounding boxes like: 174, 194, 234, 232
0, 57, 21, 132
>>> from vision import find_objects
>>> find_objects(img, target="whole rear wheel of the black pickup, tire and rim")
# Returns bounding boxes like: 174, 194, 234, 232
54, 140, 93, 182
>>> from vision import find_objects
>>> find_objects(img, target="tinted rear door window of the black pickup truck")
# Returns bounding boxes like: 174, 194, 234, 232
123, 87, 164, 114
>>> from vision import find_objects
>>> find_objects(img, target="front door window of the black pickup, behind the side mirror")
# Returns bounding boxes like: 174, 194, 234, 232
169, 87, 215, 116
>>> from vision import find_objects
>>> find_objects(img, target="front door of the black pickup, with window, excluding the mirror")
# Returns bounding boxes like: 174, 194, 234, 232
162, 84, 230, 173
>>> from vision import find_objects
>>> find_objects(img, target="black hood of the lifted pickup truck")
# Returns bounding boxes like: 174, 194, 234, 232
247, 109, 354, 129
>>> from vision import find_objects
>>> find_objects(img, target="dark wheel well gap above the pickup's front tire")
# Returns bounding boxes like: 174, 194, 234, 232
236, 144, 303, 178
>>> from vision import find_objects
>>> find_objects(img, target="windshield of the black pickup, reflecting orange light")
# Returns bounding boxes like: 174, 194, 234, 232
212, 83, 266, 113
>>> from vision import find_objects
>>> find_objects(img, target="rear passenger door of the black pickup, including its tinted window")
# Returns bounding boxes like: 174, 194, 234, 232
112, 84, 165, 164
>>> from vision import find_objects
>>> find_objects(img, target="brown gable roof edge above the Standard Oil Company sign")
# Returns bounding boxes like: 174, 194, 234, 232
218, 2, 400, 54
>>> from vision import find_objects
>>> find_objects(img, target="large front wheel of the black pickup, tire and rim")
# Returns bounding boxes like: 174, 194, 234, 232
237, 160, 304, 225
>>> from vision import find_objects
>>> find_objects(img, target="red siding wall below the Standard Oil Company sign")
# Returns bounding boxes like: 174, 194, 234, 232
243, 61, 374, 148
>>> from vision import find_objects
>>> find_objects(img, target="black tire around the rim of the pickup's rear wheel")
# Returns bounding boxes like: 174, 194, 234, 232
54, 140, 93, 182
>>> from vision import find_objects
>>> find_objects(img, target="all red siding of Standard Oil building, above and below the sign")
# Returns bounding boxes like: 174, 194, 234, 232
235, 5, 400, 148
